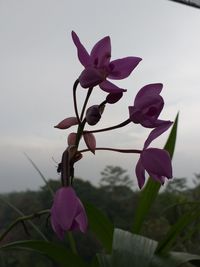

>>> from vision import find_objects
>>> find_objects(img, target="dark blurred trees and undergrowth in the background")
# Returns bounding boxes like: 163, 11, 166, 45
0, 171, 200, 267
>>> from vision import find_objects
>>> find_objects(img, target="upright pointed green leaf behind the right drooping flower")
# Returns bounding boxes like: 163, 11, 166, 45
132, 114, 178, 234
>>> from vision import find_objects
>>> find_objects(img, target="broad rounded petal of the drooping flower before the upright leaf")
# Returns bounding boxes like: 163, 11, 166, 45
141, 148, 172, 178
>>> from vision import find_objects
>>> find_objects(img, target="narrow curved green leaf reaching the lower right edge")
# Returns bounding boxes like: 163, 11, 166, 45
155, 209, 200, 254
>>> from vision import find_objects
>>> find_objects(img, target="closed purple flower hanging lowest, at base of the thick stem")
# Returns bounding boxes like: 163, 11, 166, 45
51, 186, 88, 239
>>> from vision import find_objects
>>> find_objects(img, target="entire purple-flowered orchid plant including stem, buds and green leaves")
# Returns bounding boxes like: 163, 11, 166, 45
1, 32, 200, 267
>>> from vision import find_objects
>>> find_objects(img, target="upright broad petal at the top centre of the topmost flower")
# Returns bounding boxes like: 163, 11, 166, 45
90, 36, 111, 68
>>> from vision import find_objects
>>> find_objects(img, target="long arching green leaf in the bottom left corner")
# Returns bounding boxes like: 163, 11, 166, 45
0, 240, 88, 267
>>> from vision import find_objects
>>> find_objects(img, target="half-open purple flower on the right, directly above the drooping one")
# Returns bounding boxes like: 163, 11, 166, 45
129, 83, 170, 128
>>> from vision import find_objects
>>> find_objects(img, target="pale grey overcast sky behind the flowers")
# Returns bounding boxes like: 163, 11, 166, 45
0, 0, 200, 192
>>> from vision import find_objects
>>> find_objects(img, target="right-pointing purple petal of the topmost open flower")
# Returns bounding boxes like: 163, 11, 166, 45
108, 57, 142, 80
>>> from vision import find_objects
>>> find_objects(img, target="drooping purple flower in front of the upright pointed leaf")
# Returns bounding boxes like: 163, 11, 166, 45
135, 122, 172, 189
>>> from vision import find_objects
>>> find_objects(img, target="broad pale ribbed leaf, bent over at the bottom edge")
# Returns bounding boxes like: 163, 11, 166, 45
98, 229, 200, 267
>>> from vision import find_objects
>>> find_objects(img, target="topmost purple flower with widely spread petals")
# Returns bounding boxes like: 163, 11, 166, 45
72, 31, 141, 93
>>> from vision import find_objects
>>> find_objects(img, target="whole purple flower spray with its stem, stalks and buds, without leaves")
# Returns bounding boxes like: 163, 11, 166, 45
51, 32, 172, 239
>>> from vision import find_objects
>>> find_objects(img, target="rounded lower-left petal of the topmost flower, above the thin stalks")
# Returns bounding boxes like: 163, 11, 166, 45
79, 67, 104, 88
